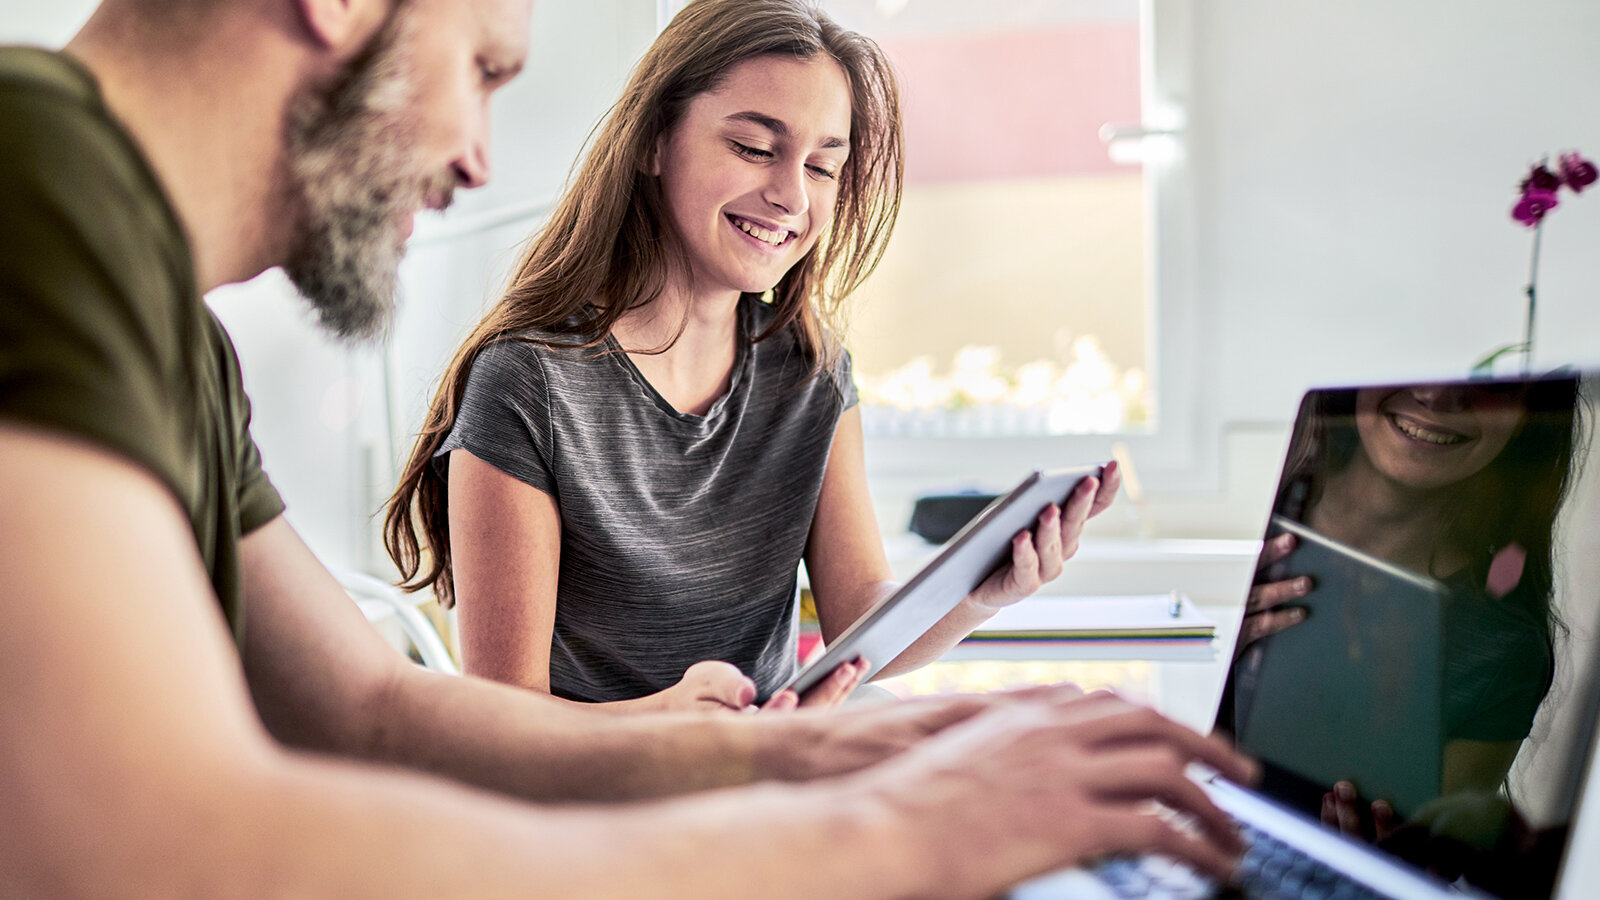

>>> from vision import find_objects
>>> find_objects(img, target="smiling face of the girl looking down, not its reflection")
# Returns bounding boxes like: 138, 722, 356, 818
651, 56, 851, 296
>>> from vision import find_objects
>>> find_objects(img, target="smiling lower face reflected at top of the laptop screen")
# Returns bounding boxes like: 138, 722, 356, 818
1355, 384, 1525, 490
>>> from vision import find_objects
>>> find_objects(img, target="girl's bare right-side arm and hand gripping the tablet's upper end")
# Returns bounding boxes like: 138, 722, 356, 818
805, 407, 1122, 677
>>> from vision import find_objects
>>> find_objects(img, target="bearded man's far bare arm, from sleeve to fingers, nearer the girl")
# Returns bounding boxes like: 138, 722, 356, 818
240, 517, 986, 801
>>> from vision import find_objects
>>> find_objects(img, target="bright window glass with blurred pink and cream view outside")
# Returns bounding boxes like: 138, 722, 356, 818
824, 0, 1152, 436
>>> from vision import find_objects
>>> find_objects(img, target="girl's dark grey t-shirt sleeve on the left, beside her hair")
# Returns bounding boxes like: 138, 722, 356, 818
434, 341, 555, 496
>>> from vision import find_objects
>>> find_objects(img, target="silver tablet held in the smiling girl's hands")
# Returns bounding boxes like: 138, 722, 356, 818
778, 466, 1101, 697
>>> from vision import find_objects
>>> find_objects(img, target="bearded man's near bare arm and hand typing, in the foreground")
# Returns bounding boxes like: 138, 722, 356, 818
0, 426, 1248, 898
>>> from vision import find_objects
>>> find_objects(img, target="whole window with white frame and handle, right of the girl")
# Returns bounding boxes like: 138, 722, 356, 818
659, 0, 1221, 509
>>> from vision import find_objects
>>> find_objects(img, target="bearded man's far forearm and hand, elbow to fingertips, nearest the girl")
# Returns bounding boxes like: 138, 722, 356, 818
360, 666, 995, 801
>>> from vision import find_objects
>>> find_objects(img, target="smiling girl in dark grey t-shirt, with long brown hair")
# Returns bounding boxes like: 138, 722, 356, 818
386, 0, 1118, 709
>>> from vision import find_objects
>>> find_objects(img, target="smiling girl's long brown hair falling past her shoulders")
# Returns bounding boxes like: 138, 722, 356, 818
384, 0, 904, 607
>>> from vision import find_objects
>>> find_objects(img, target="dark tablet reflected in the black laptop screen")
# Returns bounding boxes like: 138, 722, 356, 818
1232, 516, 1450, 817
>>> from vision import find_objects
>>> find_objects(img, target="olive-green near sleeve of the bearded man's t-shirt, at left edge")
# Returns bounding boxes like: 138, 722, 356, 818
0, 76, 192, 492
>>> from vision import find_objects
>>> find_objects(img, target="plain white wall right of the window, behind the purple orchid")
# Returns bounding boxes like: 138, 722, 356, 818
1190, 0, 1600, 421
